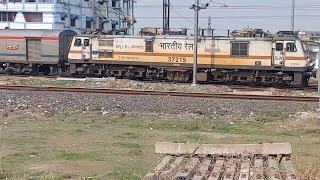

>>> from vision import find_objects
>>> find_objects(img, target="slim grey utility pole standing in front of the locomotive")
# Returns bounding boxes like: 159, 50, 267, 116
191, 0, 211, 86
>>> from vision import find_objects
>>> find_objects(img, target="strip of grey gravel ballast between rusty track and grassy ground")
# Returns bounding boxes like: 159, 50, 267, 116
0, 90, 318, 118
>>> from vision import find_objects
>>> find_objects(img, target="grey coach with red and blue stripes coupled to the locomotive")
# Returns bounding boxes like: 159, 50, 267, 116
0, 29, 76, 75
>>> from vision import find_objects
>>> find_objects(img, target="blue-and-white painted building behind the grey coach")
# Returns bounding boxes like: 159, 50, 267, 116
0, 0, 98, 31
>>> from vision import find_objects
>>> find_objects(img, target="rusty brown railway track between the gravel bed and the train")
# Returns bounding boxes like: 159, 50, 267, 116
0, 85, 319, 102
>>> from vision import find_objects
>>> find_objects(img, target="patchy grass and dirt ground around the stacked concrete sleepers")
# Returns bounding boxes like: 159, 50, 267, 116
0, 109, 320, 180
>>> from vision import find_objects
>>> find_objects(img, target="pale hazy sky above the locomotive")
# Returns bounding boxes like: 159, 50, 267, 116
135, 0, 320, 34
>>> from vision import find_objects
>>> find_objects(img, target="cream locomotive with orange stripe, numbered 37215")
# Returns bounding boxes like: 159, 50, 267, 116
68, 31, 315, 85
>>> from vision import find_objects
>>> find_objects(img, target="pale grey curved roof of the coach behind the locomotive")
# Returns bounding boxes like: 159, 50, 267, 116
0, 29, 73, 37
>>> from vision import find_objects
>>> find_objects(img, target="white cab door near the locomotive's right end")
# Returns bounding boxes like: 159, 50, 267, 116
272, 41, 286, 67
